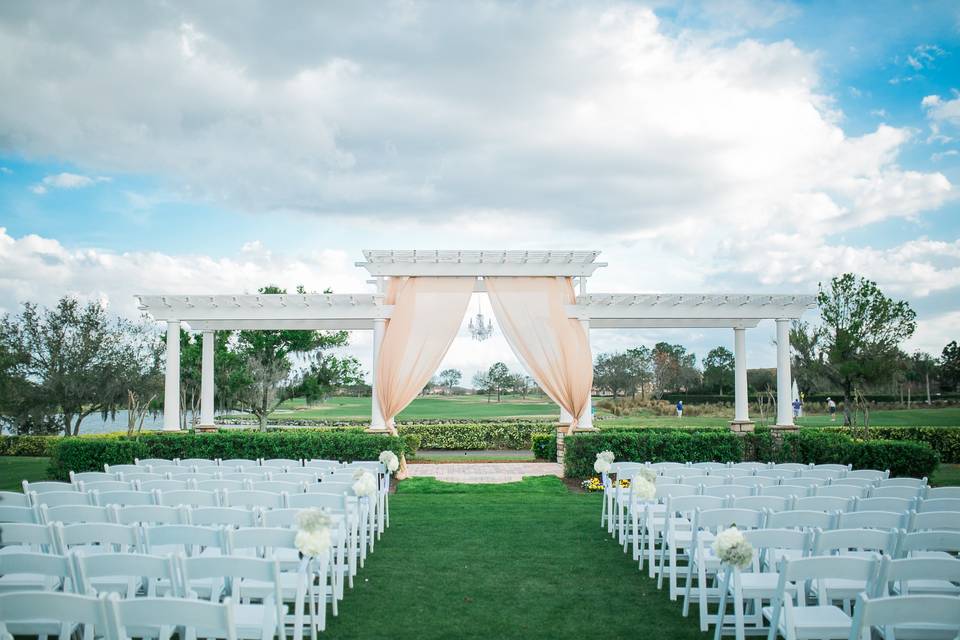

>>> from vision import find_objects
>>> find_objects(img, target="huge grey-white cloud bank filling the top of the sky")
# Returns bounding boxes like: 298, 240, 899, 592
0, 1, 950, 235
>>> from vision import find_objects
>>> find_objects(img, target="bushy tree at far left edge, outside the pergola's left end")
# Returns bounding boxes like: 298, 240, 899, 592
0, 297, 157, 435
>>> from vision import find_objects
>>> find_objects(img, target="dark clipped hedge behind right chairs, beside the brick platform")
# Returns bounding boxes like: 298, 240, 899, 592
564, 429, 743, 478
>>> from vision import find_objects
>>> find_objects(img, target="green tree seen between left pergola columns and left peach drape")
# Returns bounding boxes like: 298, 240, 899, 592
236, 285, 349, 431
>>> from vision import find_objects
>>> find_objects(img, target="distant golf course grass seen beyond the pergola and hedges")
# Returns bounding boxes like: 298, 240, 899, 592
258, 396, 960, 427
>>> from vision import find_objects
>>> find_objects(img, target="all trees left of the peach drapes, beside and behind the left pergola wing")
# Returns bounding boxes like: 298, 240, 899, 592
0, 286, 364, 435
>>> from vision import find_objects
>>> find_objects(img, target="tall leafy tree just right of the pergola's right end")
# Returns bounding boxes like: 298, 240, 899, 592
792, 273, 917, 425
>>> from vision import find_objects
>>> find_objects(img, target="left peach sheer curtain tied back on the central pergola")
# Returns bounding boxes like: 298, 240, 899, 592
375, 277, 476, 430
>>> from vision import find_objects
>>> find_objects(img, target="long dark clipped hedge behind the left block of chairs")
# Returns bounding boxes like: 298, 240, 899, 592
50, 429, 406, 480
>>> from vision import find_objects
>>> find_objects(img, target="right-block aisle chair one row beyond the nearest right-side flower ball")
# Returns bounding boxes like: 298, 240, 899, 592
683, 508, 764, 631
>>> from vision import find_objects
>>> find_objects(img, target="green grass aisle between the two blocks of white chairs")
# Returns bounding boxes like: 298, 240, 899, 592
328, 477, 708, 639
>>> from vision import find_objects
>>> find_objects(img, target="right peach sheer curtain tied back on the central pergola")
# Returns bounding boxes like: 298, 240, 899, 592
483, 277, 593, 433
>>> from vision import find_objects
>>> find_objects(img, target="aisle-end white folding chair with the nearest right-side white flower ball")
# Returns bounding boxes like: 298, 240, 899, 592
714, 528, 813, 640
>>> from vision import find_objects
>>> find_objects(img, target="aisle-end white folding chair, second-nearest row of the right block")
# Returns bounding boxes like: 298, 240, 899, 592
763, 556, 880, 640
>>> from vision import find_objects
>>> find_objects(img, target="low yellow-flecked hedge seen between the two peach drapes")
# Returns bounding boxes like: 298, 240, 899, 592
397, 421, 555, 449
